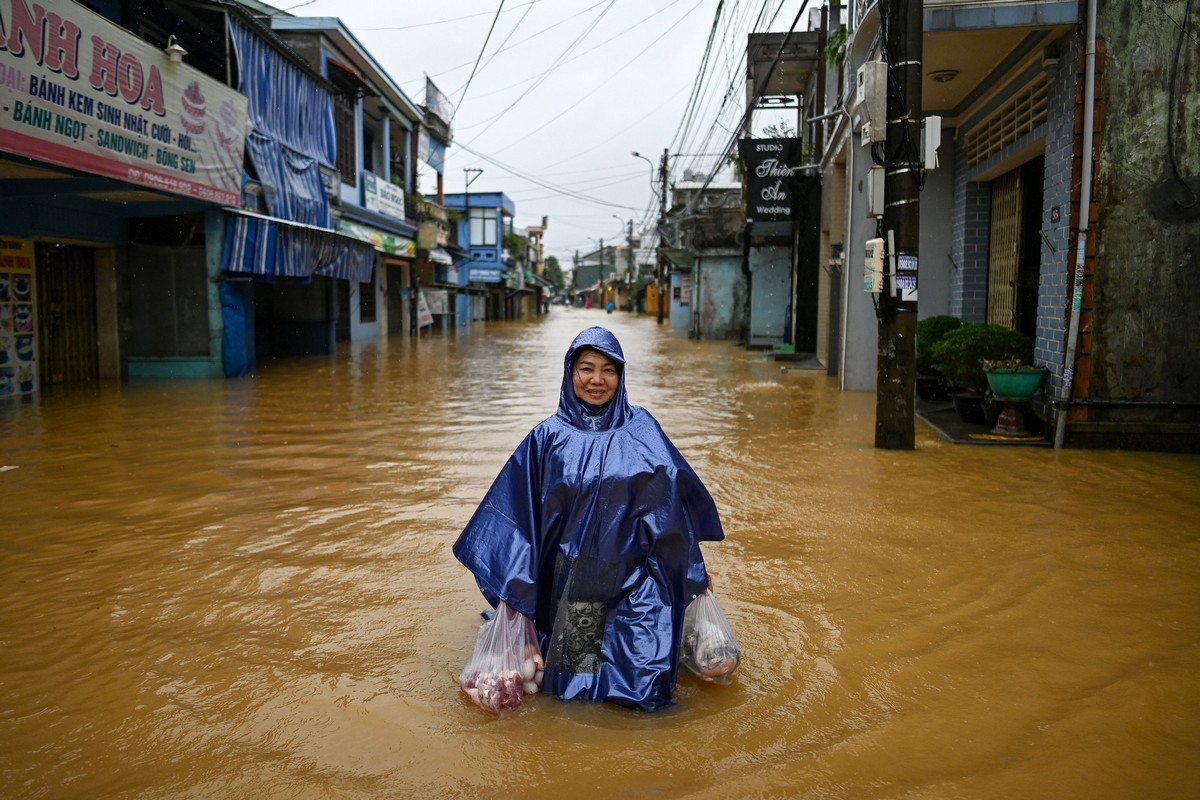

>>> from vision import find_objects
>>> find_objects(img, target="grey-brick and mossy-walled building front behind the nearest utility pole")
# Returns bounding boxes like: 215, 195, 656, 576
772, 0, 1200, 450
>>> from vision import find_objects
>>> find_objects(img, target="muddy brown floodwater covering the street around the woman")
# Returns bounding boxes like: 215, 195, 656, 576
0, 309, 1200, 800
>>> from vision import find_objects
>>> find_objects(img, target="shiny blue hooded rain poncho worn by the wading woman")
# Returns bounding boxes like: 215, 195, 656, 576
454, 327, 725, 710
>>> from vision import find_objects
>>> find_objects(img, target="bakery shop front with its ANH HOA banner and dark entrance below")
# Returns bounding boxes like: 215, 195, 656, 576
0, 0, 246, 395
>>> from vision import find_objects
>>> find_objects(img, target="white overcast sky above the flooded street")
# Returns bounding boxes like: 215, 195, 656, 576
272, 0, 823, 267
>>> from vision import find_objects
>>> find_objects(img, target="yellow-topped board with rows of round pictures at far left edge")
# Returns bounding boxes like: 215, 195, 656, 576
0, 239, 37, 397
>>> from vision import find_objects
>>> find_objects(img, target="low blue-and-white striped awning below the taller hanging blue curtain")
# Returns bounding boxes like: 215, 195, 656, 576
221, 209, 376, 283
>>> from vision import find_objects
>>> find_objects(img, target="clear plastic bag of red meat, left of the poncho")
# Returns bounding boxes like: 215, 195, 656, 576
458, 601, 546, 714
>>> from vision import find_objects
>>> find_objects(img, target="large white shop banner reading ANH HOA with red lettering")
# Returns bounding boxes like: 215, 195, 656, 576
0, 0, 247, 205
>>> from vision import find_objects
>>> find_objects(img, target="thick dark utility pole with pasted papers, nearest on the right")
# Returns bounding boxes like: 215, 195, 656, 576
872, 0, 924, 450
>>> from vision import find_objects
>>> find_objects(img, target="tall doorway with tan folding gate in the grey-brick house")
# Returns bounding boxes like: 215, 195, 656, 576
988, 156, 1045, 338
